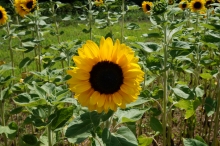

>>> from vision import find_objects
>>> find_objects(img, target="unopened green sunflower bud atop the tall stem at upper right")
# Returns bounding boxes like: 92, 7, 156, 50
153, 0, 167, 15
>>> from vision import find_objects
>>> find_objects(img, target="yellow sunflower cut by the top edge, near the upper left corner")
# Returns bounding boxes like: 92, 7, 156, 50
14, 0, 37, 17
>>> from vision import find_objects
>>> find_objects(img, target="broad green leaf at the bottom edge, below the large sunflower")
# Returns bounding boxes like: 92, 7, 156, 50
102, 126, 138, 146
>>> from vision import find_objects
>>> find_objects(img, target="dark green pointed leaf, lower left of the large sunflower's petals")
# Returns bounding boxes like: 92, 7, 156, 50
51, 106, 73, 130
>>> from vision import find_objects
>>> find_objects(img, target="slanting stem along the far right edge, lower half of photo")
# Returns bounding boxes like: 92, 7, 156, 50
212, 69, 220, 146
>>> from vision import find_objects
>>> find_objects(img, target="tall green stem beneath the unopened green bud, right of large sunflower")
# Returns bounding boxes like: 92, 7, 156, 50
162, 14, 169, 146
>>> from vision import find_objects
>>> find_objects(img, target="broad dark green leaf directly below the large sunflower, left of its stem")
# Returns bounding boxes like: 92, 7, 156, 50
65, 111, 101, 138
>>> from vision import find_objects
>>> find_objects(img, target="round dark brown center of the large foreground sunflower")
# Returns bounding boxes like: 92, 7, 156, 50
89, 61, 124, 94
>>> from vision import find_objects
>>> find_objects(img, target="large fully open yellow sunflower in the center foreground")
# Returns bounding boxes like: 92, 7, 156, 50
67, 37, 144, 113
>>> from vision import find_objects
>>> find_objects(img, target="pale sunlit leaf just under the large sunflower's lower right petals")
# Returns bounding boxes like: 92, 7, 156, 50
115, 109, 146, 123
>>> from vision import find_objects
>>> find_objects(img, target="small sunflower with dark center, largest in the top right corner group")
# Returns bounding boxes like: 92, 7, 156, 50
189, 0, 206, 12
